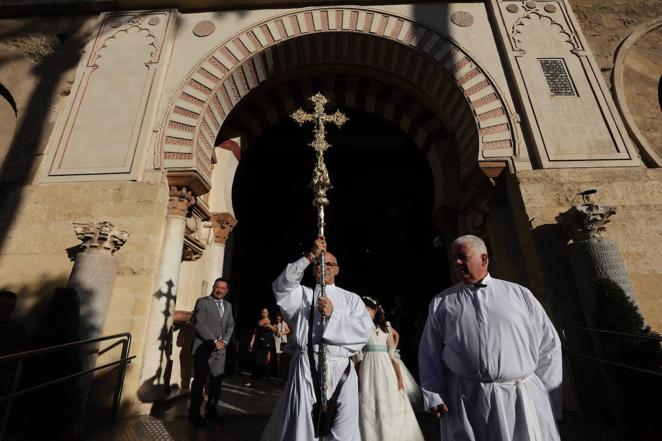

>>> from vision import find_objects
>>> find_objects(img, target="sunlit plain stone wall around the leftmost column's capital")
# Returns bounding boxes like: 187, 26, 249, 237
0, 180, 168, 410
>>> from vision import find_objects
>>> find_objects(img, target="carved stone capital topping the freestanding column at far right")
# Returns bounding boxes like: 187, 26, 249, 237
556, 202, 616, 243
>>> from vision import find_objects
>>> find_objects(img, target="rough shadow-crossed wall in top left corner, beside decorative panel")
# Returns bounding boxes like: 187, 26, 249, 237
0, 17, 95, 182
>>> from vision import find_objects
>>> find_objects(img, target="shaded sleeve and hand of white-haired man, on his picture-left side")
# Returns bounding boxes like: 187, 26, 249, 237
418, 299, 445, 411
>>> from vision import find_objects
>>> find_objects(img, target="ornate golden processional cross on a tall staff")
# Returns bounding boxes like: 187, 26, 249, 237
290, 92, 348, 406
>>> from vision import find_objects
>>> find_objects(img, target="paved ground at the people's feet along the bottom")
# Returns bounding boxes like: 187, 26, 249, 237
89, 373, 623, 441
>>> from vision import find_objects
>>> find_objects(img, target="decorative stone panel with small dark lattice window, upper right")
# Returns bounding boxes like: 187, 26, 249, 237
489, 0, 640, 168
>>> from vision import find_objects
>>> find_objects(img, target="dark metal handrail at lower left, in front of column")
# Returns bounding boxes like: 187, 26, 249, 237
0, 332, 136, 430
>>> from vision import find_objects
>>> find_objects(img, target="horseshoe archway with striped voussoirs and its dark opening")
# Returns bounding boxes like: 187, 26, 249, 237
162, 14, 514, 374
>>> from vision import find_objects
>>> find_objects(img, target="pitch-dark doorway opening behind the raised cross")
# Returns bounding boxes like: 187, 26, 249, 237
232, 109, 450, 370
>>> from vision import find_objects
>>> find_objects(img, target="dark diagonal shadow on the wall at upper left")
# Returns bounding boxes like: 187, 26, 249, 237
0, 17, 89, 254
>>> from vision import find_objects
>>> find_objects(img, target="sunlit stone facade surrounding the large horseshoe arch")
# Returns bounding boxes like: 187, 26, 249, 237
0, 0, 662, 420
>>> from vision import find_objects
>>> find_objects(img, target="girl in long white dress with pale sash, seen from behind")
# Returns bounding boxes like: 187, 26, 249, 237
357, 297, 423, 441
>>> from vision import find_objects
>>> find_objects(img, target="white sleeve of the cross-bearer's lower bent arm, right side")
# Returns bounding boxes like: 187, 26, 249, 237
324, 296, 375, 352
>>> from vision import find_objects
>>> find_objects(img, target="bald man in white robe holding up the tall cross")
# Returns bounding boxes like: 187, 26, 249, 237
262, 238, 375, 441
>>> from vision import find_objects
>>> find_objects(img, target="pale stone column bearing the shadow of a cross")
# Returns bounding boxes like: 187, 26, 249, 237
138, 186, 195, 401
